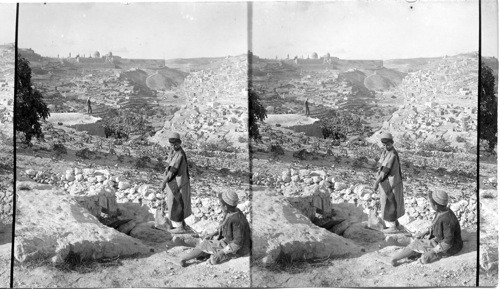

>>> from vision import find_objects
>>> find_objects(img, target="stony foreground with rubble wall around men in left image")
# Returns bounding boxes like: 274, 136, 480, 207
14, 120, 249, 287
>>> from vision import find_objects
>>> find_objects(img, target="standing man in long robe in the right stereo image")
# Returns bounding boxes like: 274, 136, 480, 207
373, 133, 405, 233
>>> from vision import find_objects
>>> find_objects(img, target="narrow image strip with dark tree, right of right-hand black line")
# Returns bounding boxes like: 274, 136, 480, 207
478, 0, 498, 287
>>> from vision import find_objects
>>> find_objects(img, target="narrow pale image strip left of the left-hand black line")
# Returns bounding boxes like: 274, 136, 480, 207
0, 4, 16, 288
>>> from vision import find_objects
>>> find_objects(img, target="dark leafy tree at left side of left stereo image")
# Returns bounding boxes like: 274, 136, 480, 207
15, 57, 50, 143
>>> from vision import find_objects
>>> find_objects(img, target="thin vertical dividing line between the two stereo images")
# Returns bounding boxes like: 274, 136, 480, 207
247, 2, 253, 287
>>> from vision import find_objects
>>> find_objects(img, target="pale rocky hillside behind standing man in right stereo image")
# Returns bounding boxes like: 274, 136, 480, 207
370, 54, 478, 151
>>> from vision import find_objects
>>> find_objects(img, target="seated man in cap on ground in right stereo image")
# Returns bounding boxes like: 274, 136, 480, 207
391, 192, 463, 266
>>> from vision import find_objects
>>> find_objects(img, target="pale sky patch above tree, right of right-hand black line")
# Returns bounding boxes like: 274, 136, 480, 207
481, 0, 498, 58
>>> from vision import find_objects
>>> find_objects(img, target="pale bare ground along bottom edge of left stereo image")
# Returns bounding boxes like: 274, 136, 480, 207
14, 247, 250, 288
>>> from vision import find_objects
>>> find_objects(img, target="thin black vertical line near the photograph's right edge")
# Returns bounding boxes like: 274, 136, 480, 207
476, 0, 482, 287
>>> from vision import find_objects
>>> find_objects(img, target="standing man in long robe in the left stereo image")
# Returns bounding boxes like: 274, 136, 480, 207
161, 132, 192, 234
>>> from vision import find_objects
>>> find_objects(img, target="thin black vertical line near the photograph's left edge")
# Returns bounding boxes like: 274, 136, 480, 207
10, 3, 19, 288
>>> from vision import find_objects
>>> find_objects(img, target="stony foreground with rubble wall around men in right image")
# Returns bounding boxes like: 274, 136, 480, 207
252, 126, 477, 287
